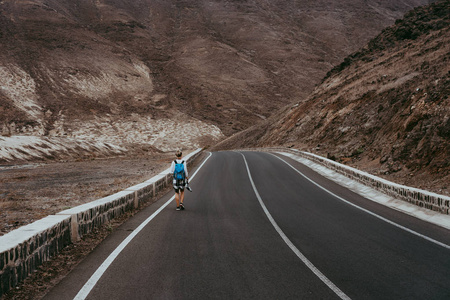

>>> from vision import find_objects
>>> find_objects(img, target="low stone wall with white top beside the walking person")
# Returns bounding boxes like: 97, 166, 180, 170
0, 149, 202, 297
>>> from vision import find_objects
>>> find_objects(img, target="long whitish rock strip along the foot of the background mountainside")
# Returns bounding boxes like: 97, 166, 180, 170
0, 113, 224, 161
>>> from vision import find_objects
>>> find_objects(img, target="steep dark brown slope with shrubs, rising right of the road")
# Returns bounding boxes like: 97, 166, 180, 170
216, 0, 450, 194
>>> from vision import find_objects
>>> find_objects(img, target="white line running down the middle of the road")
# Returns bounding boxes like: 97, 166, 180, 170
240, 153, 350, 299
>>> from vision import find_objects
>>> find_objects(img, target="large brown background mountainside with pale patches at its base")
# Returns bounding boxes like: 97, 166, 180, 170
0, 0, 428, 161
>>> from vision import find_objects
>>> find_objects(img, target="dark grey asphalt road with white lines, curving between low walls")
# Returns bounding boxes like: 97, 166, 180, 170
45, 152, 450, 300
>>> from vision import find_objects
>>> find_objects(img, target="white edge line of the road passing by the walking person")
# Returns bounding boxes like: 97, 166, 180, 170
74, 153, 212, 300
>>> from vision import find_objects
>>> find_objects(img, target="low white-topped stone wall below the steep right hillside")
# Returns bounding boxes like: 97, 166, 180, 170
268, 148, 450, 215
